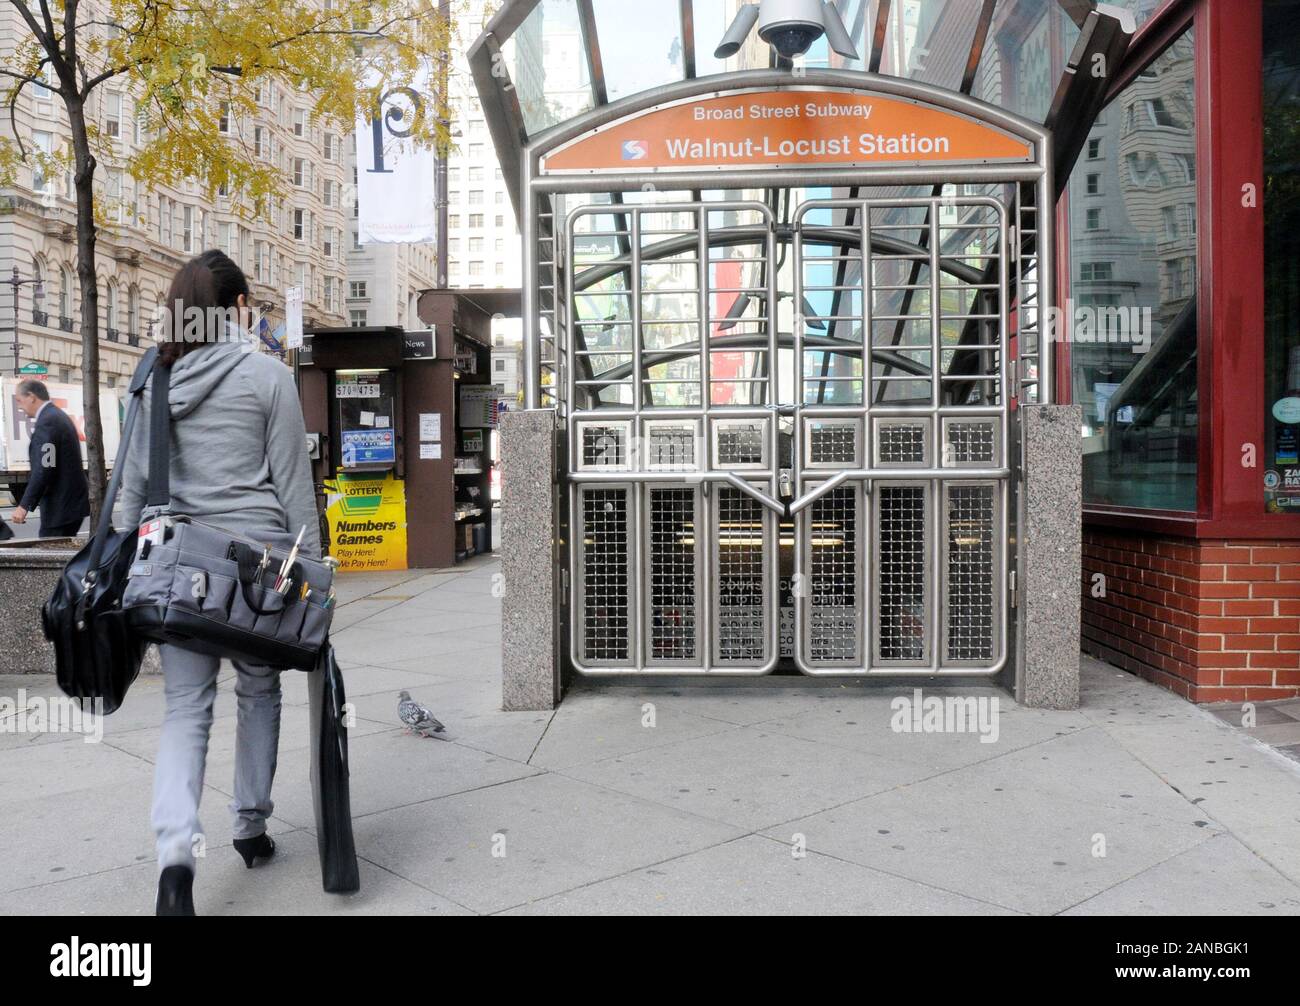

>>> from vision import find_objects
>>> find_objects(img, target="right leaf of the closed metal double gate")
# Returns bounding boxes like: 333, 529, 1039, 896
789, 199, 1010, 675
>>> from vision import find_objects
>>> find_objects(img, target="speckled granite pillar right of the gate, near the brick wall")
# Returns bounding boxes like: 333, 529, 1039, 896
1015, 406, 1083, 710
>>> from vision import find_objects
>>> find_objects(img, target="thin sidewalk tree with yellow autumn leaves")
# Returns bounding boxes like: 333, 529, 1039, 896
0, 0, 450, 521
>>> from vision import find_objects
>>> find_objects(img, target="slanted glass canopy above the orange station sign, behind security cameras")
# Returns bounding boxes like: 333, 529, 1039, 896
488, 0, 1166, 146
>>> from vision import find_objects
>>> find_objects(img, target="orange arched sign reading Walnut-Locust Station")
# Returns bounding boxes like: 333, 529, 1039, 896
542, 88, 1034, 174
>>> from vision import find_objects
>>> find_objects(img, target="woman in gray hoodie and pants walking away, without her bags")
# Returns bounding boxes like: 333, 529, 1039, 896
122, 251, 320, 915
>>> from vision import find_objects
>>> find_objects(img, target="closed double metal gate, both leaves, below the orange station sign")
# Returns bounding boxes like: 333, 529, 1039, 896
566, 191, 1013, 675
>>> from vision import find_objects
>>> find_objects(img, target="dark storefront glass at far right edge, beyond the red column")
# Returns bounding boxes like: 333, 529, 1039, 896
1262, 0, 1300, 513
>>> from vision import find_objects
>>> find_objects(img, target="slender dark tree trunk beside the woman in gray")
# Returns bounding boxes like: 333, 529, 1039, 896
65, 97, 107, 528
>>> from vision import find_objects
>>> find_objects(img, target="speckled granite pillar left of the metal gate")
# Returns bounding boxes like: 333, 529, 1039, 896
501, 409, 560, 711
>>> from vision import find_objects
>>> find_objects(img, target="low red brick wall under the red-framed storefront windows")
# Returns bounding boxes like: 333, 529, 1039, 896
1083, 528, 1300, 702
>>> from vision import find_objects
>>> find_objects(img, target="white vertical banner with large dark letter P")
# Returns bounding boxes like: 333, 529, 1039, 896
356, 66, 438, 244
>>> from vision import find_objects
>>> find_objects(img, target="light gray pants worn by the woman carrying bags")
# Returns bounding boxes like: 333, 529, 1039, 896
152, 646, 280, 871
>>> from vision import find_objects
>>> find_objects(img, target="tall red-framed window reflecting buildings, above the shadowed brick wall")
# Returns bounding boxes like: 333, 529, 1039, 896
1056, 32, 1199, 511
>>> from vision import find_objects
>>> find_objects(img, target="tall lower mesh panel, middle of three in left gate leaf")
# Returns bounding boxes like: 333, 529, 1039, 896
650, 489, 696, 660
